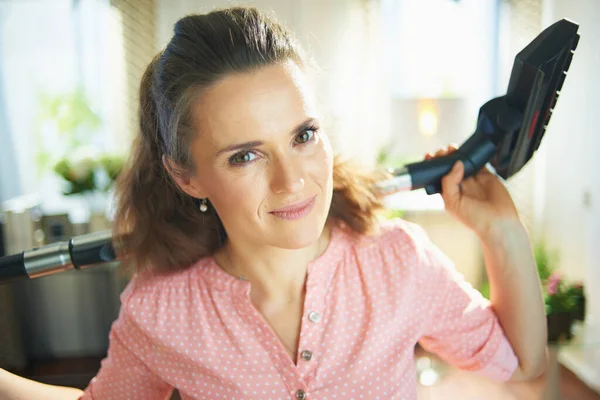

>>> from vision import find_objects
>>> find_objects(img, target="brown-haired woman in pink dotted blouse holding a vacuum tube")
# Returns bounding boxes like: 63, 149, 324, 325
0, 8, 546, 399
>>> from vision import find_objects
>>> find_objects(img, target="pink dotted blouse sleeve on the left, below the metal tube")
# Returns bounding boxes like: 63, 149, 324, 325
79, 278, 173, 400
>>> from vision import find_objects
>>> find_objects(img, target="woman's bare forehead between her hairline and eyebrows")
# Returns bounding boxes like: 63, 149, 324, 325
193, 62, 317, 144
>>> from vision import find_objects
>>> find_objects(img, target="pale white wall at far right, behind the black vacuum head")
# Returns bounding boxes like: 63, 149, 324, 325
539, 0, 600, 390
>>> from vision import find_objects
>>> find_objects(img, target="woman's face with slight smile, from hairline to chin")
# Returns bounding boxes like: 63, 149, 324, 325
185, 61, 333, 249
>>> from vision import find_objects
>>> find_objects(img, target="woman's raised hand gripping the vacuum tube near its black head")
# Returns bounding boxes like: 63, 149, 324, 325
425, 145, 519, 238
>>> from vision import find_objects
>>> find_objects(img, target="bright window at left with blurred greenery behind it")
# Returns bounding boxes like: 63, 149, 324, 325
0, 0, 127, 219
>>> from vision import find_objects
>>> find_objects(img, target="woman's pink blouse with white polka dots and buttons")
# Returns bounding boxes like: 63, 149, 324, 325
81, 219, 517, 400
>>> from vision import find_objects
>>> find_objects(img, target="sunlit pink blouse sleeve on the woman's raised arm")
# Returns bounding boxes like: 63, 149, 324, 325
404, 225, 518, 381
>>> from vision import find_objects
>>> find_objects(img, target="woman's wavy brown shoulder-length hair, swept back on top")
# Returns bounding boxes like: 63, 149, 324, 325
113, 7, 382, 273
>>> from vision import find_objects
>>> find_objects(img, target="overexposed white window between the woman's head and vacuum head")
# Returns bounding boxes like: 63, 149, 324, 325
382, 0, 498, 101
